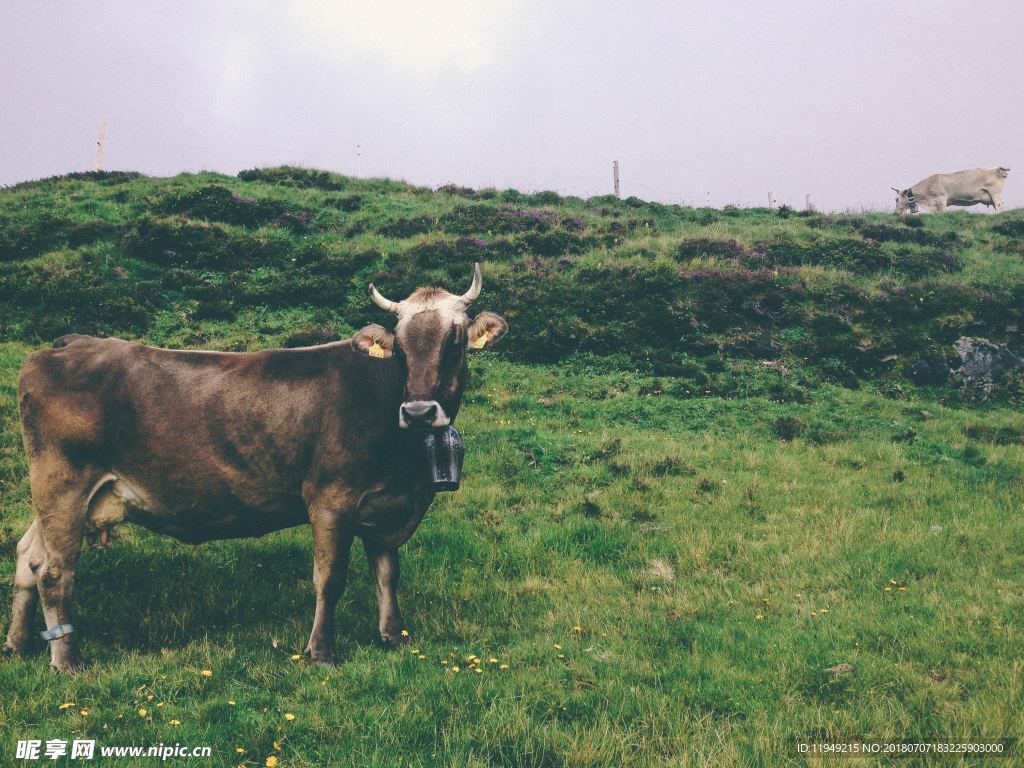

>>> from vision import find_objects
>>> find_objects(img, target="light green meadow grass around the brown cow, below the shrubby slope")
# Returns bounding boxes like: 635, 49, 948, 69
0, 345, 1024, 766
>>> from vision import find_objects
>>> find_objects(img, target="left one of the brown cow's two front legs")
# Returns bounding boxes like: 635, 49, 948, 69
306, 517, 352, 665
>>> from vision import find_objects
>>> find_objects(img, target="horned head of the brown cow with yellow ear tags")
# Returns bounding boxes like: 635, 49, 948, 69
352, 264, 508, 429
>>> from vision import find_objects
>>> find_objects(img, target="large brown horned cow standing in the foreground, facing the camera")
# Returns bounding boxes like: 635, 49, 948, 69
4, 264, 508, 670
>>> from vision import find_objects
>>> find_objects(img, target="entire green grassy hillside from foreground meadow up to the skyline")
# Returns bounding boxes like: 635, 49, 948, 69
0, 169, 1024, 768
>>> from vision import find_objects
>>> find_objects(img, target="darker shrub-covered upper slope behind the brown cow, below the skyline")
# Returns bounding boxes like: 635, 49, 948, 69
0, 168, 1024, 394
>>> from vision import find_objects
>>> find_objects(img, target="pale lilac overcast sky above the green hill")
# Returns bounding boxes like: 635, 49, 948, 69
0, 0, 1024, 210
